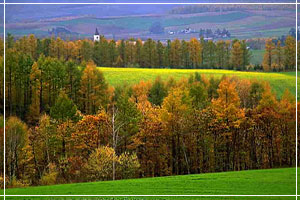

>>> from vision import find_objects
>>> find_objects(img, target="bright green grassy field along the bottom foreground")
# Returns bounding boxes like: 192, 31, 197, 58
6, 168, 296, 199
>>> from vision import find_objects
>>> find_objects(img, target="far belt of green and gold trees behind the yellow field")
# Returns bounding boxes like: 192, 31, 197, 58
7, 35, 296, 71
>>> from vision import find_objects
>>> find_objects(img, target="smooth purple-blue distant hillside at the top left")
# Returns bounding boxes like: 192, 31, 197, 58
2, 5, 178, 22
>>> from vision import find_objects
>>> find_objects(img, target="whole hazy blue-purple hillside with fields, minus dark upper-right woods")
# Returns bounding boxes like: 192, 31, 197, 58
6, 5, 295, 40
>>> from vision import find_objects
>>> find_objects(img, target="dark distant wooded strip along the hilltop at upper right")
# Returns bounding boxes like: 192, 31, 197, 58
170, 4, 295, 14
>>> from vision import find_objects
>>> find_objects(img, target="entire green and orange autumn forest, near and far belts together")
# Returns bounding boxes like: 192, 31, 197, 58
0, 35, 296, 187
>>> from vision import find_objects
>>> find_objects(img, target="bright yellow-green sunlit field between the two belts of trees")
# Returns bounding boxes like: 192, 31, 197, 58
99, 67, 299, 97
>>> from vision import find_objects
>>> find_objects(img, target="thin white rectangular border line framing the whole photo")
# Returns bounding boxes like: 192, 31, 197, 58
0, 0, 300, 200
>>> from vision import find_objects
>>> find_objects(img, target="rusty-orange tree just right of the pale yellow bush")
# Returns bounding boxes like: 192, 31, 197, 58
132, 98, 171, 177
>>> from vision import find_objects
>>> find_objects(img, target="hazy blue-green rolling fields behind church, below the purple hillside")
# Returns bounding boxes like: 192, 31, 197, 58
6, 10, 295, 40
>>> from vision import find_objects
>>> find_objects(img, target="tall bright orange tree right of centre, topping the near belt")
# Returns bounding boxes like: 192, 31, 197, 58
212, 78, 244, 170
